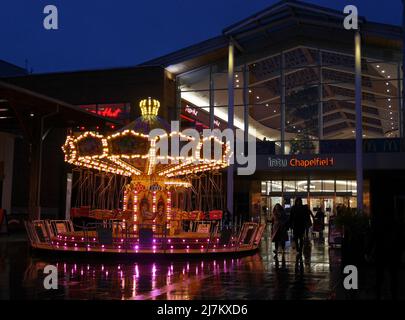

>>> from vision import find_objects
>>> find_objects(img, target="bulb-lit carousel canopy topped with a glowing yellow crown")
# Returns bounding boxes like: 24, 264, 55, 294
62, 98, 230, 179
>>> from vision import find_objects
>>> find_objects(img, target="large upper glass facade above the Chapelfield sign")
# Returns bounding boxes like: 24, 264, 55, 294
178, 46, 402, 154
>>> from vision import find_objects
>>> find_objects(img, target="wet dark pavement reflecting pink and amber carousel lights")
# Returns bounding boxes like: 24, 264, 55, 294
0, 228, 340, 299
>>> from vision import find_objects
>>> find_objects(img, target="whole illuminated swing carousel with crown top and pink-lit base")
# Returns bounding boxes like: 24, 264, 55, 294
26, 98, 265, 254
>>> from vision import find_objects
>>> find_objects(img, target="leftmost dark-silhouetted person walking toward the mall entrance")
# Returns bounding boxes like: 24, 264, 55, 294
270, 203, 288, 259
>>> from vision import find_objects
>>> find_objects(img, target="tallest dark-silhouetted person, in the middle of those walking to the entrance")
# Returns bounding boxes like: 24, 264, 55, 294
289, 198, 311, 262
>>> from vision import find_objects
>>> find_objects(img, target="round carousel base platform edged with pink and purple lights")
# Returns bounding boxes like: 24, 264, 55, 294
25, 220, 265, 256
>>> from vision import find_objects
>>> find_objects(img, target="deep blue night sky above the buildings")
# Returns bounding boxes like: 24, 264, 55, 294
0, 0, 402, 73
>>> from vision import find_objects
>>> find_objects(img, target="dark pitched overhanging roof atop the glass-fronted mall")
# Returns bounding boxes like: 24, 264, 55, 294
140, 0, 403, 74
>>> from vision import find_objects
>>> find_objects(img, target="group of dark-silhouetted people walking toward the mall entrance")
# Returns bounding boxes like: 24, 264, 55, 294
271, 198, 325, 262
